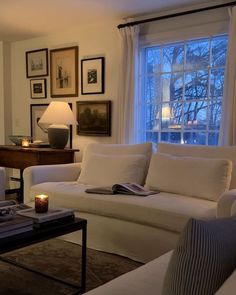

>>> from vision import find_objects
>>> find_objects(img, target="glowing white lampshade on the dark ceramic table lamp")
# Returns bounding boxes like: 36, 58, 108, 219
39, 101, 77, 125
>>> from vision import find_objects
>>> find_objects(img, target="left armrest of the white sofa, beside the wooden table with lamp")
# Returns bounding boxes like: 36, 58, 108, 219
23, 163, 81, 202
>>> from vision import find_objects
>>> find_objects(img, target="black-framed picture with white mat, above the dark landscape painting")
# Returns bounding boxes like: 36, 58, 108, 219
81, 57, 105, 94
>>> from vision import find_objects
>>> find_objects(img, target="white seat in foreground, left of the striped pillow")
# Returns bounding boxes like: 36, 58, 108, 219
84, 251, 172, 295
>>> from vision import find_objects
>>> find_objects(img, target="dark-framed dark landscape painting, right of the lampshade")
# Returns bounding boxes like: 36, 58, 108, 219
76, 100, 111, 136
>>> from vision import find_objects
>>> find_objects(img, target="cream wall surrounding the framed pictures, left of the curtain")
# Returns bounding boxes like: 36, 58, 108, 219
11, 20, 120, 159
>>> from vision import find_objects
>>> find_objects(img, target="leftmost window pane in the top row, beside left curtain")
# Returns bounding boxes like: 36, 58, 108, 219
146, 47, 161, 74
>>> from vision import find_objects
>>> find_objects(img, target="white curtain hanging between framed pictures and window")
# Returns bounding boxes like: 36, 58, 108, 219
118, 26, 139, 143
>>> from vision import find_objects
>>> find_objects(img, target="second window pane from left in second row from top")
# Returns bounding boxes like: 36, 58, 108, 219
161, 74, 183, 102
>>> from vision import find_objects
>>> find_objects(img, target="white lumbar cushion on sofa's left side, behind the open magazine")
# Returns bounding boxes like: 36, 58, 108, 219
78, 153, 146, 186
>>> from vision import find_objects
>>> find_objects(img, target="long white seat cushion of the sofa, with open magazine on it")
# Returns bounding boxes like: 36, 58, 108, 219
28, 182, 217, 232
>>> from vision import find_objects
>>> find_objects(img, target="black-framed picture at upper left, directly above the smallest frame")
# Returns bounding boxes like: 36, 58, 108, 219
25, 48, 48, 78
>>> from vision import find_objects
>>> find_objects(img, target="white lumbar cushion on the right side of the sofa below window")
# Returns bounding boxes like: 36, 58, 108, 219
146, 153, 232, 201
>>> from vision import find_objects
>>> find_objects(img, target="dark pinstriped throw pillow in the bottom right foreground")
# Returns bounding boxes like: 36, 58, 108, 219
162, 218, 236, 295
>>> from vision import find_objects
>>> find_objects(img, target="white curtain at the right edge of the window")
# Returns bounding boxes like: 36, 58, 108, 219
219, 6, 236, 145
